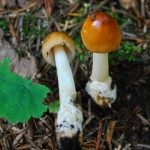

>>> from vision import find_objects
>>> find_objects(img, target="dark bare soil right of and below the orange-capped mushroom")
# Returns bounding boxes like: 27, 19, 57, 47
80, 62, 150, 150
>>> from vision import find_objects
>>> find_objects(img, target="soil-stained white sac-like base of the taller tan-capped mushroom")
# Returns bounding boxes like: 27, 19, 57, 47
56, 98, 83, 150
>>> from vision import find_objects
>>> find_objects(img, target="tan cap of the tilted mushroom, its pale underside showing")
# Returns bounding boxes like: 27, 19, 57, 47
42, 32, 75, 66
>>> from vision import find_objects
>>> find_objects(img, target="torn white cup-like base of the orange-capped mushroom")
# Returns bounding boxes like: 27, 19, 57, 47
86, 77, 117, 107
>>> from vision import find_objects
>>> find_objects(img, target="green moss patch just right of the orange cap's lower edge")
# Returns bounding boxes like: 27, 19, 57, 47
109, 41, 141, 63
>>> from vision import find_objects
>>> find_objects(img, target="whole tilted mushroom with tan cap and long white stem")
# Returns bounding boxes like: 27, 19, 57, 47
42, 32, 83, 149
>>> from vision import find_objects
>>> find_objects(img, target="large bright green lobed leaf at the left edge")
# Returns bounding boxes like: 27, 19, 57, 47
0, 58, 50, 123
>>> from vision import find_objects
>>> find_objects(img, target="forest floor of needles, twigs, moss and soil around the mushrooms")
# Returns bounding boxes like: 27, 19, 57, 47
0, 0, 150, 150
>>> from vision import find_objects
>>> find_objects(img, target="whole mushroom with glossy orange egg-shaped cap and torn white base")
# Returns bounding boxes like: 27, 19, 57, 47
81, 12, 121, 107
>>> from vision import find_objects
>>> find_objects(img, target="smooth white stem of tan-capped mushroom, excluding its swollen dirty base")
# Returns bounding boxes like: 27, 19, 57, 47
54, 46, 76, 103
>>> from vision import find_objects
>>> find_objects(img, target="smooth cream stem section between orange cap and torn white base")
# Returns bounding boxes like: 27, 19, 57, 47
91, 53, 109, 82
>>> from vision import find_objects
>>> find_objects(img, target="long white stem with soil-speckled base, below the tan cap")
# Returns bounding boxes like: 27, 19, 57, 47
53, 46, 83, 147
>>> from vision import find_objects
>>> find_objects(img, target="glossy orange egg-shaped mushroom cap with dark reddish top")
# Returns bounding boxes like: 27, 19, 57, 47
81, 12, 121, 53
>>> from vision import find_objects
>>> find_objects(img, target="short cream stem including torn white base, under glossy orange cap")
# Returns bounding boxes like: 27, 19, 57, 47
86, 53, 116, 107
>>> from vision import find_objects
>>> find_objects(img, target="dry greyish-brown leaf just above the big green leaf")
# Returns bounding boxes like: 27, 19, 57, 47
0, 41, 37, 78
